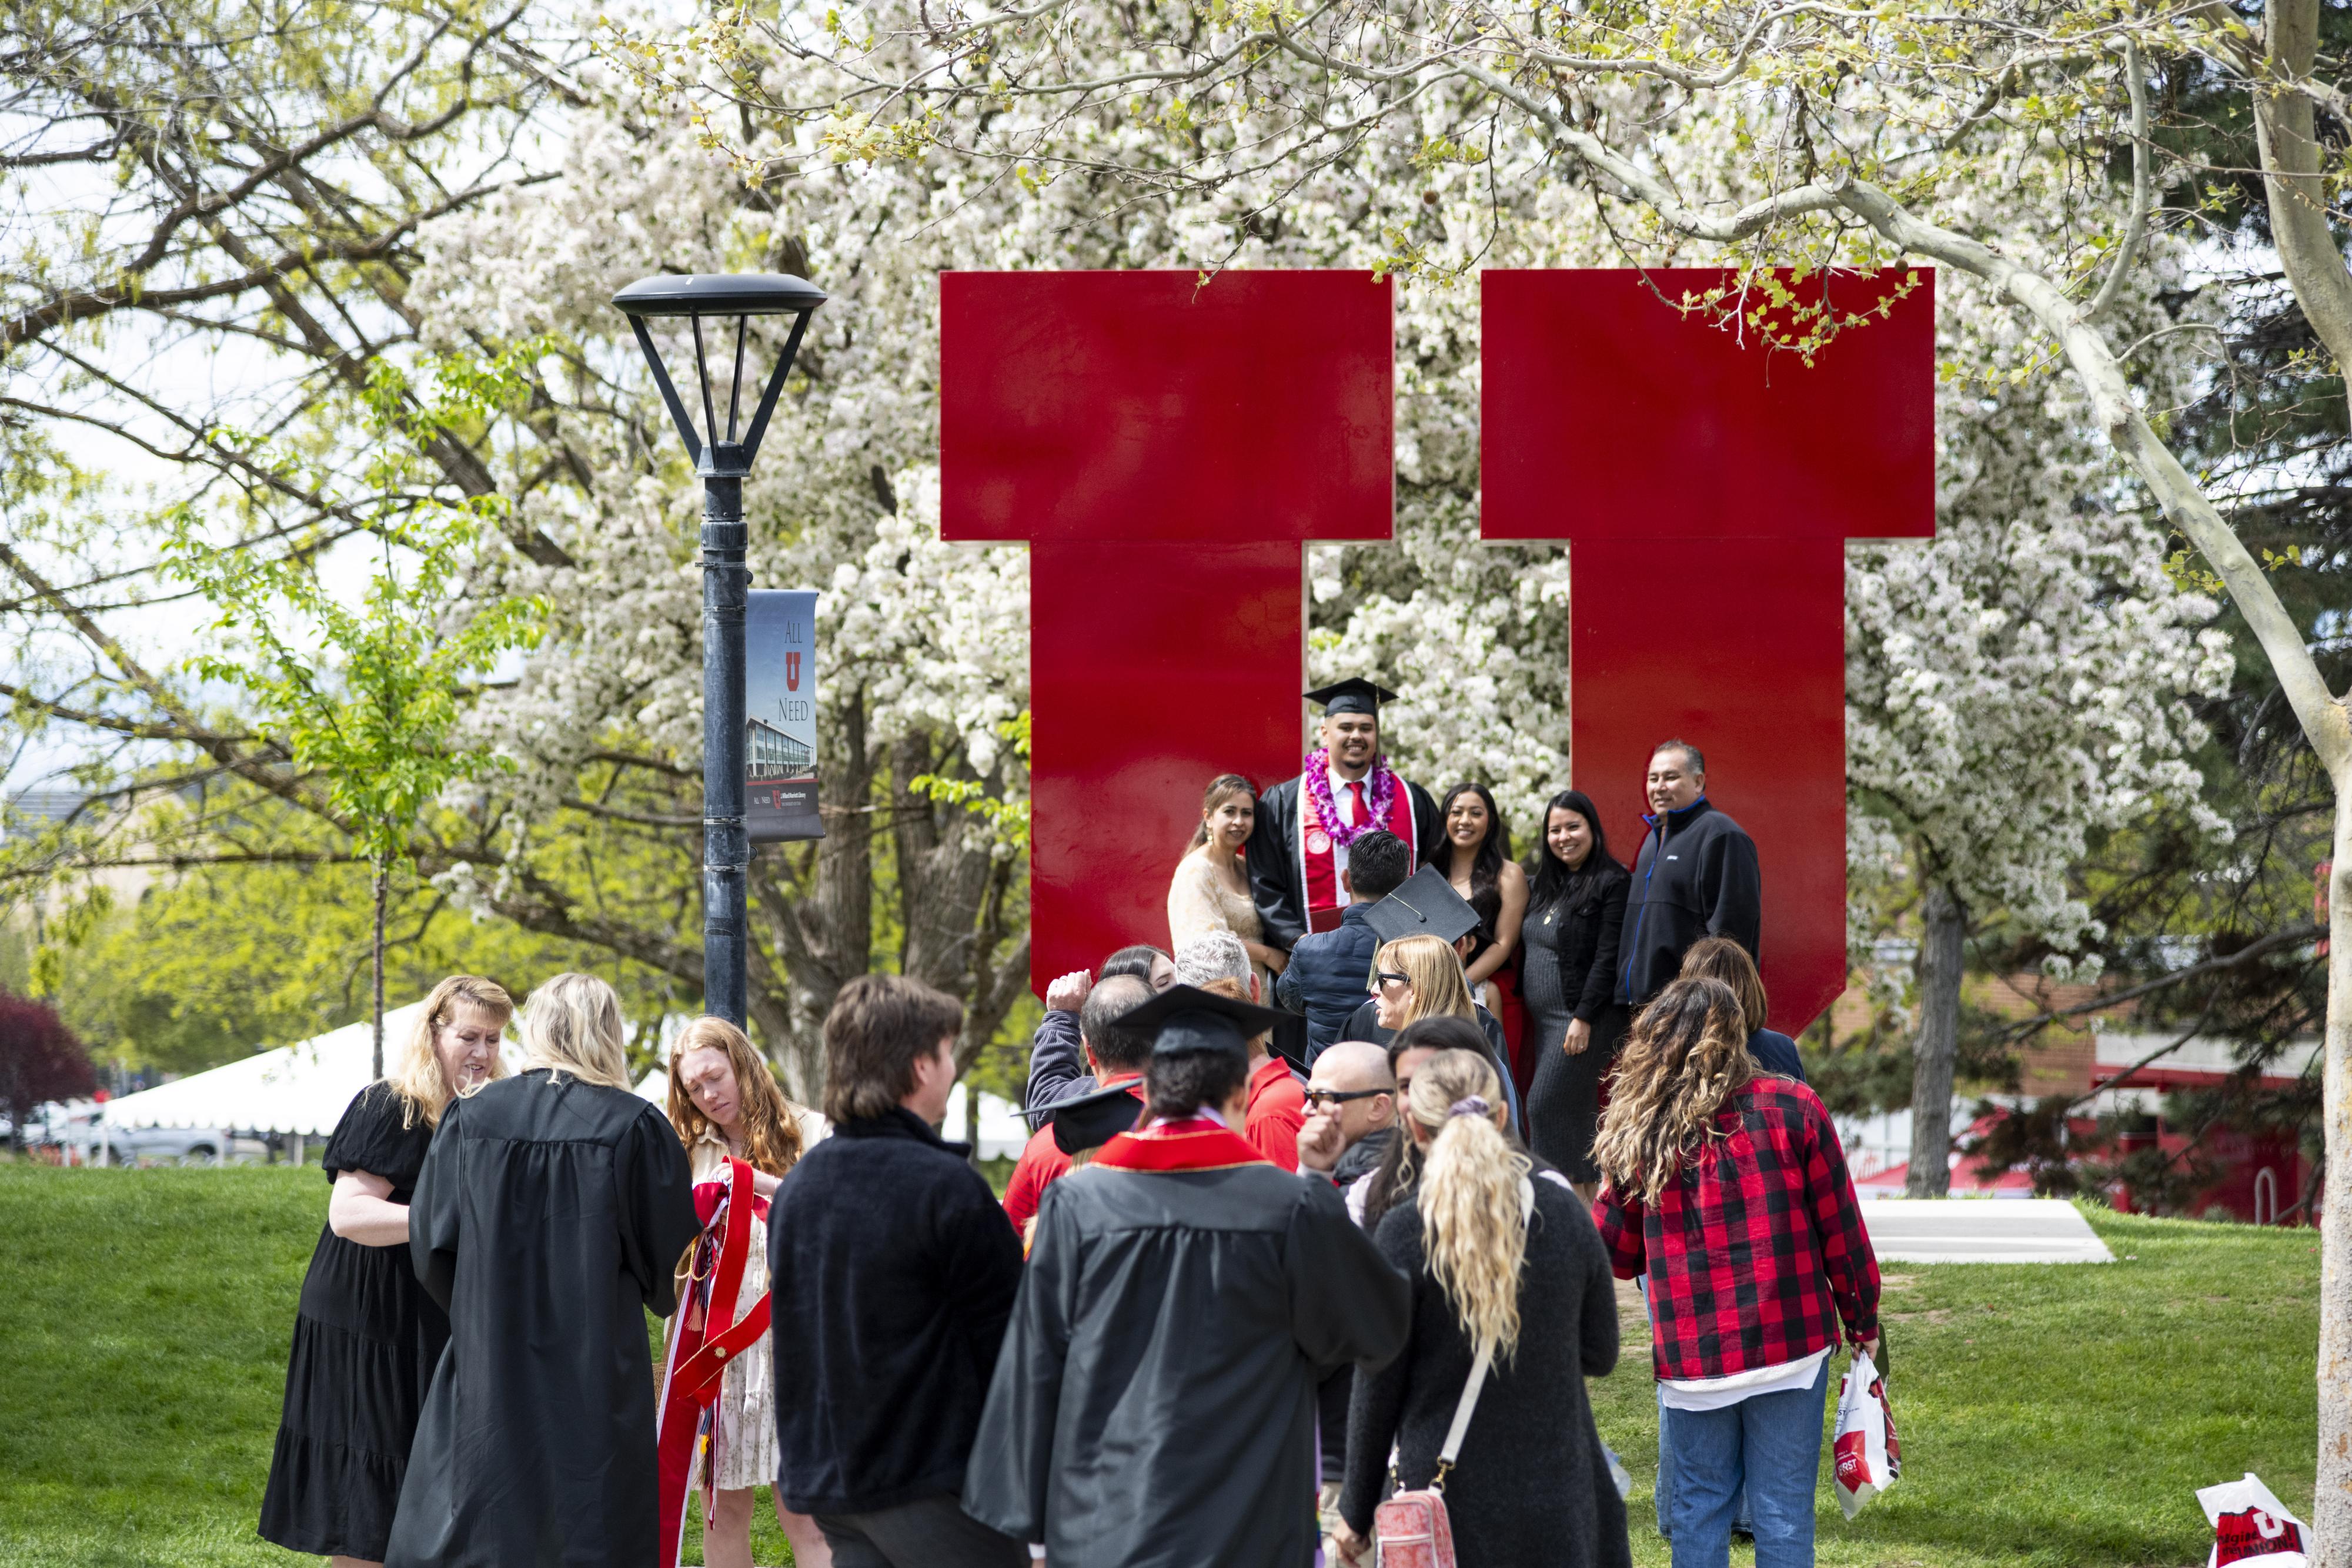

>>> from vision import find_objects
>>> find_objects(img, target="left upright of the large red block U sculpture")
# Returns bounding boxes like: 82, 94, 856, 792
938, 273, 1395, 992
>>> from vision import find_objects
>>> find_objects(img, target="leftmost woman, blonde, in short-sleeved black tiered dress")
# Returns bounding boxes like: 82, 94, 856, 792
261, 975, 515, 1568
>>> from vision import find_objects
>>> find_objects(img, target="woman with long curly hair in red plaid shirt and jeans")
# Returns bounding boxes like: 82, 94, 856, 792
1592, 978, 1879, 1568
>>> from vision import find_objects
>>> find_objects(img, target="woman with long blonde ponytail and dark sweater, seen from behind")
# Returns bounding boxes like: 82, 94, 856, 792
1334, 1051, 1632, 1568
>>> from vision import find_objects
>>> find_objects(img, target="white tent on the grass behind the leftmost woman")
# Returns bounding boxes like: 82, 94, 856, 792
103, 1001, 501, 1138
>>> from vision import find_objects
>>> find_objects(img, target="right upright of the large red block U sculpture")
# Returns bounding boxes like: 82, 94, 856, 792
1479, 270, 1936, 1032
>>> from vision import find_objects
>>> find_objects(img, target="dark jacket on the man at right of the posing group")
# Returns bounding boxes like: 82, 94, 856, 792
1616, 797, 1764, 1006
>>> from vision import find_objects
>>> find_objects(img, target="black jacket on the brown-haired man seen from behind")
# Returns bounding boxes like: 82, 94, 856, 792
776, 1109, 1021, 1514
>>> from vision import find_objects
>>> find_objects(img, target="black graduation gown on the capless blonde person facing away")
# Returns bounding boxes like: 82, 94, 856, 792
383, 1069, 699, 1568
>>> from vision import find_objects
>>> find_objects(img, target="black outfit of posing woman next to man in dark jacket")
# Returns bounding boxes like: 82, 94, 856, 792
1519, 860, 1632, 1182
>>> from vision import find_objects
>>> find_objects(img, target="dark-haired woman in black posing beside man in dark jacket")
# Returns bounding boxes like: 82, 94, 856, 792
1522, 790, 1632, 1203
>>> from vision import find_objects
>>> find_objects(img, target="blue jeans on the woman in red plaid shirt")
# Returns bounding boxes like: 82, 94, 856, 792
1658, 1359, 1830, 1568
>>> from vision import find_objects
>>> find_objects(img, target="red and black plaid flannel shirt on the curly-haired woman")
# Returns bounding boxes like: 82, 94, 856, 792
1592, 1074, 1879, 1378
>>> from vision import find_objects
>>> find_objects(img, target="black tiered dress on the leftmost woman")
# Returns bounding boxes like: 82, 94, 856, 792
261, 1084, 449, 1561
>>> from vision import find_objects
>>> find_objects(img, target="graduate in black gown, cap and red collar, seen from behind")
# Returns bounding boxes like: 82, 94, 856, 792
964, 985, 1411, 1568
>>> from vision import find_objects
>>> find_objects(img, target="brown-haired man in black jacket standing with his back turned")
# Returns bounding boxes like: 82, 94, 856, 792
767, 975, 1028, 1568
